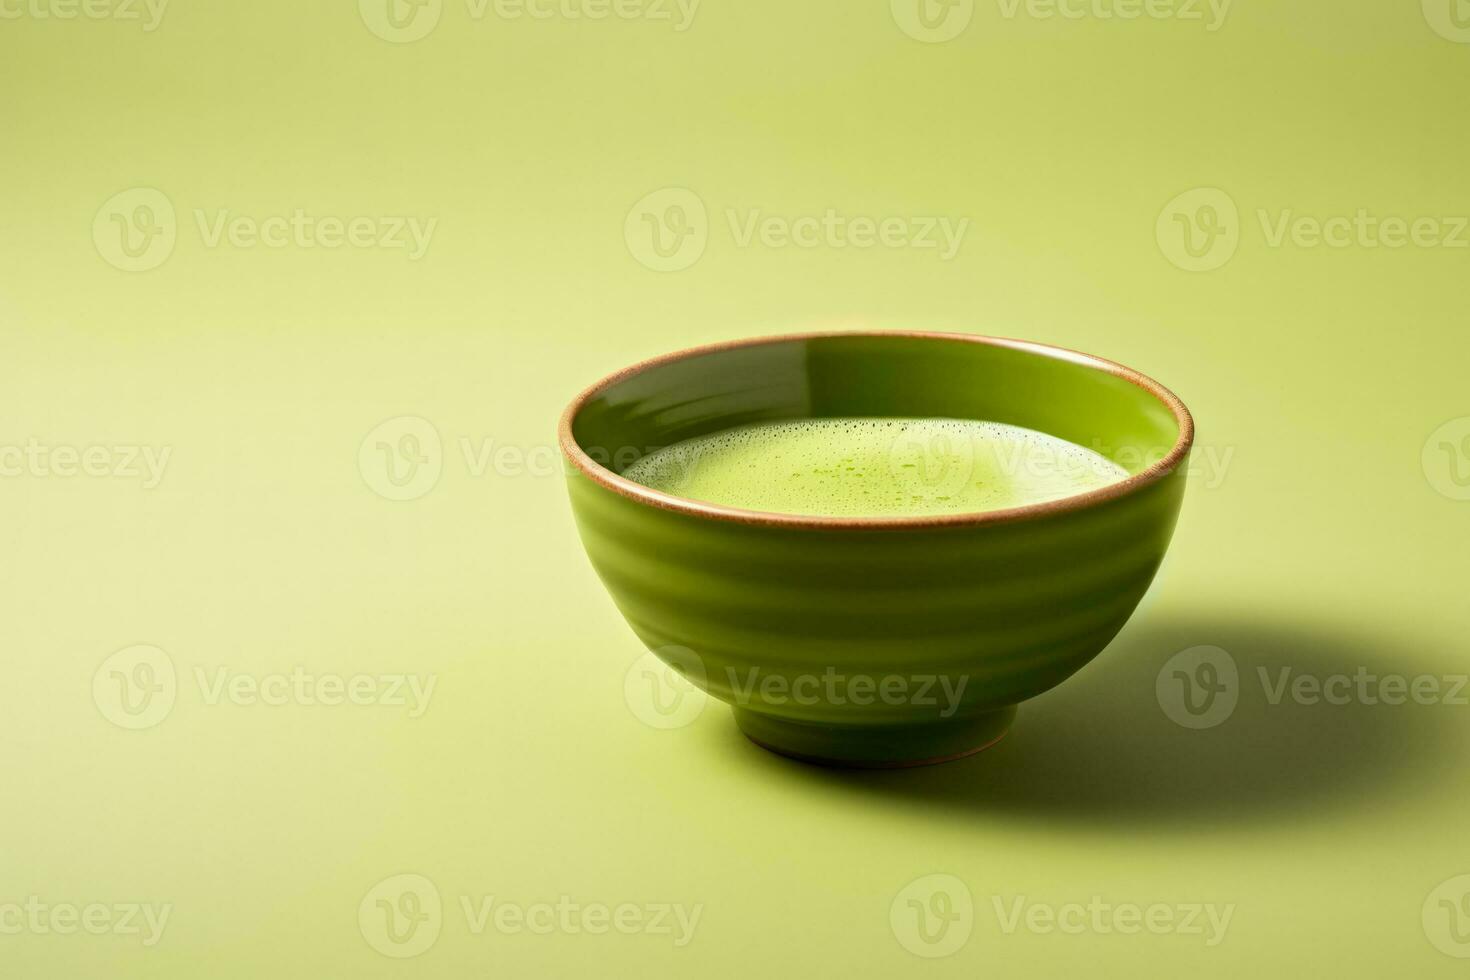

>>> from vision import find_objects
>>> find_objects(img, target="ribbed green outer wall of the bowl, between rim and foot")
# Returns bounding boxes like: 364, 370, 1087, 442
569, 460, 1186, 726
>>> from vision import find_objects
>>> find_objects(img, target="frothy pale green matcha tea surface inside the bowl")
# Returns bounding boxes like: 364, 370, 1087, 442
623, 419, 1127, 517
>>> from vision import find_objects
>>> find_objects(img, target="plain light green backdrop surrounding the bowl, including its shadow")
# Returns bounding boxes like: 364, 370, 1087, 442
0, 0, 1470, 980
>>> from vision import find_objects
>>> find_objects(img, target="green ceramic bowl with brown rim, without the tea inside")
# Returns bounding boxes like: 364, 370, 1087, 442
560, 334, 1194, 767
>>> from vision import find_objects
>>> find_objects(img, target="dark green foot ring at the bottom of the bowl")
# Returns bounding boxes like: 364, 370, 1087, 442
734, 705, 1016, 768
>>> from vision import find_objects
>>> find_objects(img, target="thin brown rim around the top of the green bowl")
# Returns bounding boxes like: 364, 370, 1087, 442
557, 331, 1194, 530
